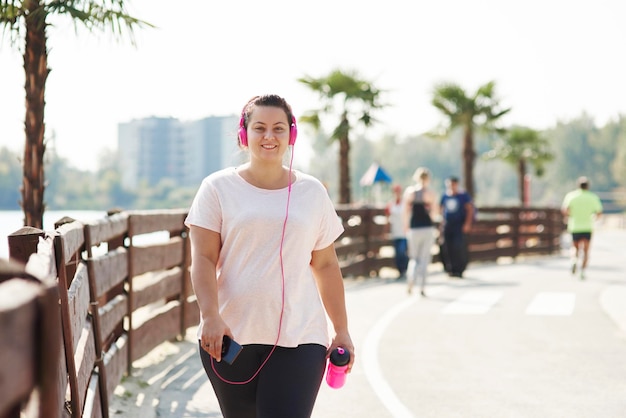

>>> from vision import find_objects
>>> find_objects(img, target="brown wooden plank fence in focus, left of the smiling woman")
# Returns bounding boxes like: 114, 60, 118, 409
0, 210, 198, 418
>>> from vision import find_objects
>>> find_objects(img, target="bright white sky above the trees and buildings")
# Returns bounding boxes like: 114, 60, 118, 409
0, 0, 626, 170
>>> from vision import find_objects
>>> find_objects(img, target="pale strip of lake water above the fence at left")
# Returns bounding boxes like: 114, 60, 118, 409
0, 210, 106, 259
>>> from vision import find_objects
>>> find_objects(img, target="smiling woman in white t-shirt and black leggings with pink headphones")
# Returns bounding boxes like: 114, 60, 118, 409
185, 95, 354, 418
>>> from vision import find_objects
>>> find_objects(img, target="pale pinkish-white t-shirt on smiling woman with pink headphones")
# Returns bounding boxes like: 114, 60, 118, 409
185, 167, 343, 347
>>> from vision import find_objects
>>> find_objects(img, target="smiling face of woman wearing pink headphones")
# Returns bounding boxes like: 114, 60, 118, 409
248, 106, 290, 162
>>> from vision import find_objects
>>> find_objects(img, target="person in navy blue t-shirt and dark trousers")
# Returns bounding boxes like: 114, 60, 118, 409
440, 177, 474, 278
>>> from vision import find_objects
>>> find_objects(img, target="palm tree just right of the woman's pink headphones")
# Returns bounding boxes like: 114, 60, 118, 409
298, 70, 382, 203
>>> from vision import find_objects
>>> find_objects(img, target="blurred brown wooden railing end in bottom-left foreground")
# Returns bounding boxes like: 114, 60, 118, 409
0, 246, 63, 418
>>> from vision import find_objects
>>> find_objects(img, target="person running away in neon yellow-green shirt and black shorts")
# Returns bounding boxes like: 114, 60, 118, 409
561, 176, 603, 280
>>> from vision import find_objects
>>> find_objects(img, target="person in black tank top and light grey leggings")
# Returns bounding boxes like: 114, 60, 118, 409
404, 167, 437, 296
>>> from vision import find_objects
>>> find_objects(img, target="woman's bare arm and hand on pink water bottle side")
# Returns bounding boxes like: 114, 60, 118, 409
311, 244, 354, 372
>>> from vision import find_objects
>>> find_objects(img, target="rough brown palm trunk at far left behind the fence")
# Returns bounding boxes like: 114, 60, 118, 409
21, 1, 49, 229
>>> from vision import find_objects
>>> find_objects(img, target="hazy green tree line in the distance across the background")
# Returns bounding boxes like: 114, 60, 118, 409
0, 114, 626, 210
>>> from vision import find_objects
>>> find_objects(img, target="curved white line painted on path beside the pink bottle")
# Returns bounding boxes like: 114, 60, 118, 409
362, 297, 416, 418
